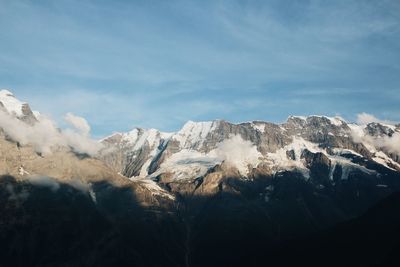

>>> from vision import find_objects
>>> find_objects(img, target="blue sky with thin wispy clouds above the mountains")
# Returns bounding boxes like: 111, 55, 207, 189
0, 0, 400, 137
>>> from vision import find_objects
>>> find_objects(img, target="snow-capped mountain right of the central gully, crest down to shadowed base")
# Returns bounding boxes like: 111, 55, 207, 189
101, 112, 400, 266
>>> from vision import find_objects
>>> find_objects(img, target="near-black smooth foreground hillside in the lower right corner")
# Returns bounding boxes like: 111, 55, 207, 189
271, 192, 400, 266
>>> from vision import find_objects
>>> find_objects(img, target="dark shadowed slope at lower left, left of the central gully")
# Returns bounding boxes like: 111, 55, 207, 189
0, 176, 183, 266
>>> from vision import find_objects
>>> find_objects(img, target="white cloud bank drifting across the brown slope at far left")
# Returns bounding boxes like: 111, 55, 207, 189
0, 111, 102, 156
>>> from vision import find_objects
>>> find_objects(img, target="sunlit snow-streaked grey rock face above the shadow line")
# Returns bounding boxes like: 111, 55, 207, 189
103, 116, 400, 196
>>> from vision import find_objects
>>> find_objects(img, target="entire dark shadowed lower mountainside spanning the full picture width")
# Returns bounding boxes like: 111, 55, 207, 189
0, 174, 400, 266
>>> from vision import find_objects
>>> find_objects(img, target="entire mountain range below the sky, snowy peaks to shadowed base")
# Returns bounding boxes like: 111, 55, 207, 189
0, 90, 400, 266
